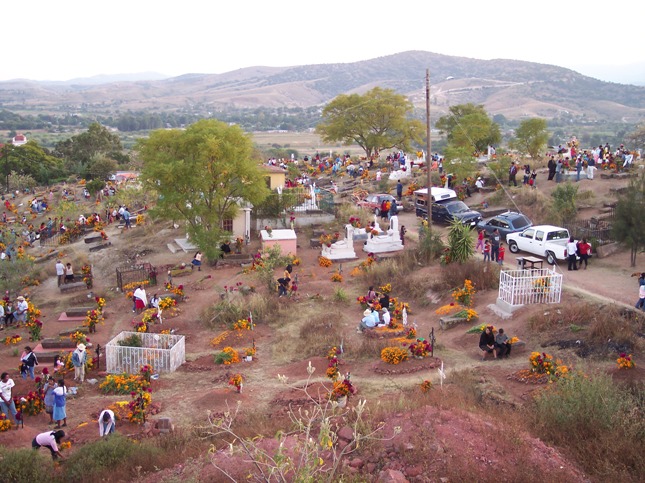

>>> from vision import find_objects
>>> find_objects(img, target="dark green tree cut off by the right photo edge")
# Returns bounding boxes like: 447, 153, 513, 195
613, 175, 645, 267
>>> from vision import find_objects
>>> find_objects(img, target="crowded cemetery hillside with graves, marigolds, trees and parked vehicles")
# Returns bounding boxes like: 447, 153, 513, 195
0, 96, 645, 483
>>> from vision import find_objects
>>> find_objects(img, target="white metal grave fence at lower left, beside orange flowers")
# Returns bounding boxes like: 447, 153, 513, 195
105, 332, 186, 374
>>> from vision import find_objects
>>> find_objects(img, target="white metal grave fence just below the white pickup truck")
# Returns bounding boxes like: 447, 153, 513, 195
499, 268, 562, 305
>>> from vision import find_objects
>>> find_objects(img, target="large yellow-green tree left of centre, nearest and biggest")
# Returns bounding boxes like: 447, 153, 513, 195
136, 120, 269, 260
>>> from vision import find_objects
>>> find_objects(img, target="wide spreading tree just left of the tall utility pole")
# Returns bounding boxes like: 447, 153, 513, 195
316, 87, 425, 158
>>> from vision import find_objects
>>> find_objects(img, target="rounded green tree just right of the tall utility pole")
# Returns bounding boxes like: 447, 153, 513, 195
436, 103, 502, 159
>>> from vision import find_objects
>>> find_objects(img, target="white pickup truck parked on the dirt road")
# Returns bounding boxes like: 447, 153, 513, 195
506, 225, 569, 265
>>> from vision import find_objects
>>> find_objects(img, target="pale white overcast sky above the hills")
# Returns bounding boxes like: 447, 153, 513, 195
0, 0, 645, 85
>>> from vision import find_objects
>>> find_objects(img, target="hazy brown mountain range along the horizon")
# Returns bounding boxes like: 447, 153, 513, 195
0, 51, 645, 124
